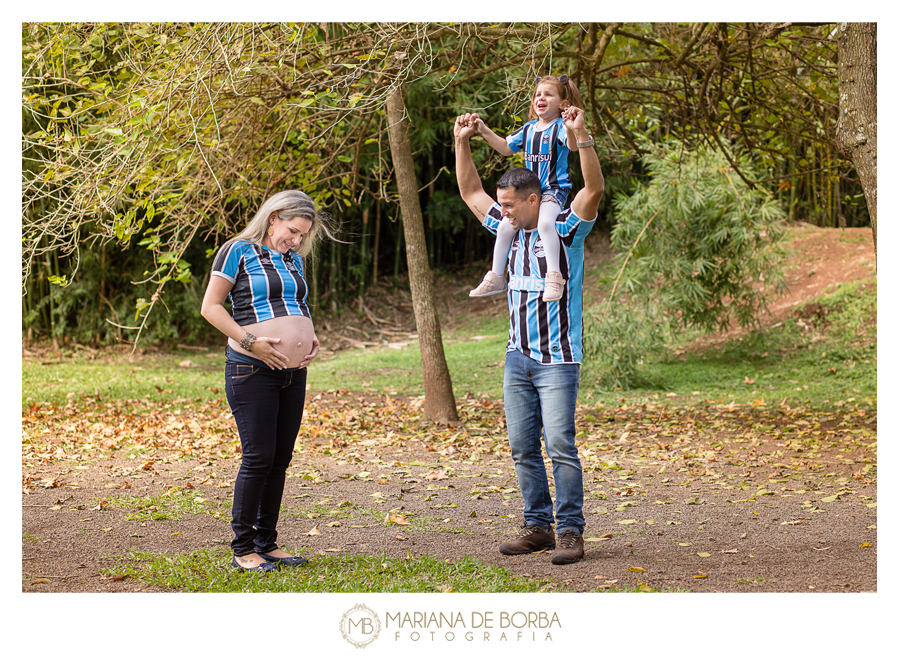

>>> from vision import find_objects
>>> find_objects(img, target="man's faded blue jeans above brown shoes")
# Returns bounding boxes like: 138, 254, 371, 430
503, 351, 585, 533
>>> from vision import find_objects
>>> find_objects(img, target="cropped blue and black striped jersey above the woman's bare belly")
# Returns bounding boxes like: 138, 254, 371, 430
212, 240, 312, 326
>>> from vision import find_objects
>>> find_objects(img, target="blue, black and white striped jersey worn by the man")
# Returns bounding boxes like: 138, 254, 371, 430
484, 203, 597, 364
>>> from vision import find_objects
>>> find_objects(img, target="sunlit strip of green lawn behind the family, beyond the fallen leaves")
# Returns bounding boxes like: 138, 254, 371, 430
22, 272, 877, 407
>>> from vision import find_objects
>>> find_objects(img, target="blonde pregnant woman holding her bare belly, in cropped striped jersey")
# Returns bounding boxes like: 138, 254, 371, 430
200, 190, 332, 572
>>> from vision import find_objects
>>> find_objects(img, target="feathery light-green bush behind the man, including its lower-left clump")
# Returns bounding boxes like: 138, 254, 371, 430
584, 142, 785, 389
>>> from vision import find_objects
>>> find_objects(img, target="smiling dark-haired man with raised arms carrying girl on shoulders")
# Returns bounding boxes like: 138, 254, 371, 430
453, 107, 604, 564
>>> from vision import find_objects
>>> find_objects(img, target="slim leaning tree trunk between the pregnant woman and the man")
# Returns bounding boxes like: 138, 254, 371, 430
387, 87, 459, 422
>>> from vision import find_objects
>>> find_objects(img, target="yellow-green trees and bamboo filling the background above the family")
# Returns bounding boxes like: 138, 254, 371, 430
22, 23, 867, 344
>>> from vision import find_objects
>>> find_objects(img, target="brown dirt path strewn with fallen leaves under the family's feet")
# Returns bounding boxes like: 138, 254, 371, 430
22, 393, 878, 592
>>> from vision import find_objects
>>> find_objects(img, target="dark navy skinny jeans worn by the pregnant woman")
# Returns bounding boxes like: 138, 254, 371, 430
225, 360, 306, 556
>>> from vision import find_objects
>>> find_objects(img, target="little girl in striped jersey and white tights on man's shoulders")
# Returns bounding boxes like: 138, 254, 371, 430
469, 74, 581, 302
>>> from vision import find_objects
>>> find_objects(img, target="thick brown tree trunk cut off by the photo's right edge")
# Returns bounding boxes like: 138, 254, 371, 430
837, 23, 878, 257
